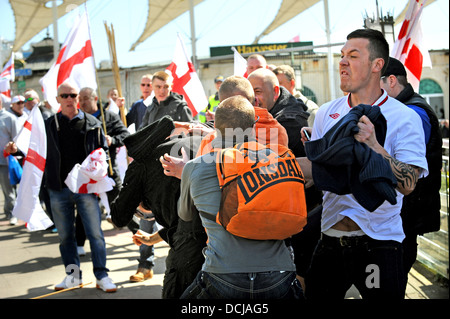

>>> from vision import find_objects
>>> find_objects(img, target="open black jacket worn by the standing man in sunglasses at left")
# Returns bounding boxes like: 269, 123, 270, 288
44, 112, 108, 191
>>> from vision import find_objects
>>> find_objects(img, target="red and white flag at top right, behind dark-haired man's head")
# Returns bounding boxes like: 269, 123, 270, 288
391, 0, 431, 92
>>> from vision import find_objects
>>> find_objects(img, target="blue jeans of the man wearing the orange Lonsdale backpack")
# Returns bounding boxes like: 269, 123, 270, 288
180, 271, 303, 299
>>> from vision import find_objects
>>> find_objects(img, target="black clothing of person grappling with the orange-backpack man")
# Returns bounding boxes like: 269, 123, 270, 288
111, 116, 207, 299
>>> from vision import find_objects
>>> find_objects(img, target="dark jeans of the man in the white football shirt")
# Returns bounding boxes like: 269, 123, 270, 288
305, 234, 405, 300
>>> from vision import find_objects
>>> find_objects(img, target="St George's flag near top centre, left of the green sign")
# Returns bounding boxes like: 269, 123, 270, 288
166, 34, 208, 116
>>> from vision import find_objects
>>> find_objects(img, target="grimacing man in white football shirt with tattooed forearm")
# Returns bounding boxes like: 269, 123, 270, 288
300, 29, 428, 300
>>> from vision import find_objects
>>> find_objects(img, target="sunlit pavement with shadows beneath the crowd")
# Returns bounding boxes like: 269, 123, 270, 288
0, 193, 449, 299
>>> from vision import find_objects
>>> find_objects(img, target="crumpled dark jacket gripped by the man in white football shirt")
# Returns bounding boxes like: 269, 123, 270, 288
305, 104, 397, 212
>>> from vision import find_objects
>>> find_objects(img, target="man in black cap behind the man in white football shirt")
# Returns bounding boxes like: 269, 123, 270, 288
380, 57, 442, 290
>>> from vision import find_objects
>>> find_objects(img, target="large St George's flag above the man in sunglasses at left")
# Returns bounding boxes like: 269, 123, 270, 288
39, 12, 97, 112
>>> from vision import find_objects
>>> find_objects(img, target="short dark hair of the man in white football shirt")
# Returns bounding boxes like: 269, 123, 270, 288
347, 29, 389, 74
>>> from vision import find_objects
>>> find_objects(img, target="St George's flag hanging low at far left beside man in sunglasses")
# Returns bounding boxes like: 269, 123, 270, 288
12, 107, 53, 231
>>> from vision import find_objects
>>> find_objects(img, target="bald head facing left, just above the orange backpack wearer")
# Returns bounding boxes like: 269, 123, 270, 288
248, 69, 280, 111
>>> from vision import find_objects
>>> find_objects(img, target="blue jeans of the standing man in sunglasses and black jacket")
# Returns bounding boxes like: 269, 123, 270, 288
48, 188, 109, 280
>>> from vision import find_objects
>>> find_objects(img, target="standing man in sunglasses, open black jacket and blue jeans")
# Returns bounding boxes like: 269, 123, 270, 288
44, 83, 117, 292
